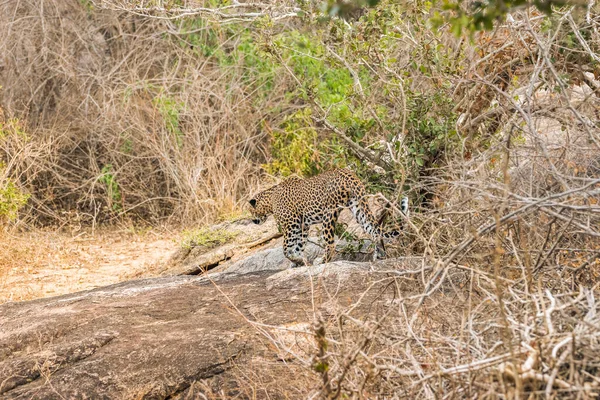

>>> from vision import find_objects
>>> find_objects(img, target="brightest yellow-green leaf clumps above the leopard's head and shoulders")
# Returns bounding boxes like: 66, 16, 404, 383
266, 29, 382, 176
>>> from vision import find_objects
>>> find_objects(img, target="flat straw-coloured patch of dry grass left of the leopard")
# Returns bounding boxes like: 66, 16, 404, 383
0, 228, 179, 303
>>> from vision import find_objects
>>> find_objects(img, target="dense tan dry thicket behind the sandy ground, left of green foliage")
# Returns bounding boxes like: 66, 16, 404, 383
0, 0, 278, 223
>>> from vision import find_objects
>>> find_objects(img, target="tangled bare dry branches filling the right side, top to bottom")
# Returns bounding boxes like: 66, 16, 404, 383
264, 9, 600, 399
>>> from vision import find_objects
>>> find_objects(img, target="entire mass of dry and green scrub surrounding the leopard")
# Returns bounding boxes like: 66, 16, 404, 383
0, 0, 600, 398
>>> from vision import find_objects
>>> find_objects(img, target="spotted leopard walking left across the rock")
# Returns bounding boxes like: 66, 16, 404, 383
249, 168, 408, 267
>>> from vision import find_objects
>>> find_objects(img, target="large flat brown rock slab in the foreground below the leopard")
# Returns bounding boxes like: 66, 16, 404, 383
0, 258, 432, 399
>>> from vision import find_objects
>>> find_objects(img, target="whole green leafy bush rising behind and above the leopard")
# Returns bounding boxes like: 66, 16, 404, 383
267, 1, 463, 206
